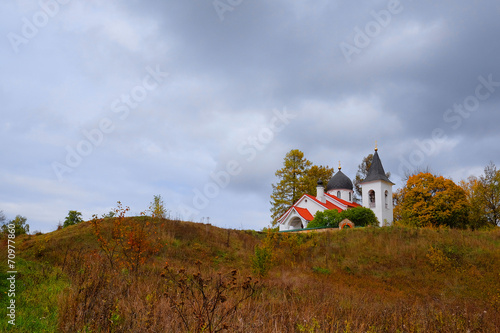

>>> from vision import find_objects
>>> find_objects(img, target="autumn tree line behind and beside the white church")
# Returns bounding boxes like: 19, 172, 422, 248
270, 149, 500, 229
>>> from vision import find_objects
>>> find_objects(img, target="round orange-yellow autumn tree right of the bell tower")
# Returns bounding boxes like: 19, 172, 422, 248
394, 173, 469, 228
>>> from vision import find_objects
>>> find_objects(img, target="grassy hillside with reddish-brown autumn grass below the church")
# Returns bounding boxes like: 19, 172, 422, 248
0, 217, 500, 333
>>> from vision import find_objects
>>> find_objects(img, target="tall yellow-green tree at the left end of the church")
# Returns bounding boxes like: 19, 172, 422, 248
271, 149, 312, 225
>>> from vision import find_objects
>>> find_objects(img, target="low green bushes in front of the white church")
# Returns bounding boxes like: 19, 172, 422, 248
307, 207, 378, 228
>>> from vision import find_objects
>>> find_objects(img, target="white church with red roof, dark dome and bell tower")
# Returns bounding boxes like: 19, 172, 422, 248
278, 148, 394, 231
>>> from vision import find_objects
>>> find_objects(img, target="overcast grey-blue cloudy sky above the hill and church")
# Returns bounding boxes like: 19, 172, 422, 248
0, 0, 500, 232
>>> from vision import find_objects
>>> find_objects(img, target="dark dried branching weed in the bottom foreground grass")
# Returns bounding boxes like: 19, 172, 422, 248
162, 261, 257, 332
